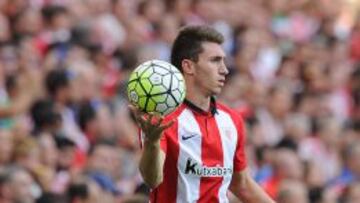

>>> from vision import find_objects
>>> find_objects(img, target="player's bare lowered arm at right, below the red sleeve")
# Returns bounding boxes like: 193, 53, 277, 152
230, 170, 275, 203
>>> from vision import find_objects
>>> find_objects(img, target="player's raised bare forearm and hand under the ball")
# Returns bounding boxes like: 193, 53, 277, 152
130, 106, 173, 188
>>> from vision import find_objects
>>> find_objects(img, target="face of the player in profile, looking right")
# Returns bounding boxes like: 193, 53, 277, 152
184, 42, 229, 96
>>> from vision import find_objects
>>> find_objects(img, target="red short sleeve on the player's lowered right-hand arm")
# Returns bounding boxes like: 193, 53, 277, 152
233, 115, 247, 172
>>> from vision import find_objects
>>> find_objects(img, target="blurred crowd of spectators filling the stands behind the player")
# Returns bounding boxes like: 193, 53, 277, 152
0, 0, 360, 203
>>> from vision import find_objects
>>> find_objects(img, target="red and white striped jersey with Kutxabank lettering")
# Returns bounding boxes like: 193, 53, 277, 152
141, 100, 246, 203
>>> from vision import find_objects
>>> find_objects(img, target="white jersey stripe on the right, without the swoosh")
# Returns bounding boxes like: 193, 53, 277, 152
215, 110, 238, 203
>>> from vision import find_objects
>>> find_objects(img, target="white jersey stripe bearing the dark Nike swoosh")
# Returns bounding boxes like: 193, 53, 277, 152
176, 109, 202, 203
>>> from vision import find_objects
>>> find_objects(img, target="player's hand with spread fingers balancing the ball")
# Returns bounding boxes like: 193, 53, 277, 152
129, 105, 174, 144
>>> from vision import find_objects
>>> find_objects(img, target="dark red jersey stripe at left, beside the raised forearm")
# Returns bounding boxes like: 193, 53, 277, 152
150, 106, 185, 203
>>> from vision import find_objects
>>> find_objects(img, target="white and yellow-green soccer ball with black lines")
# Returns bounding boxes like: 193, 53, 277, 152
127, 60, 185, 115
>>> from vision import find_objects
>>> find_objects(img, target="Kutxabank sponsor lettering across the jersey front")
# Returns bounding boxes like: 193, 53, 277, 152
185, 158, 233, 177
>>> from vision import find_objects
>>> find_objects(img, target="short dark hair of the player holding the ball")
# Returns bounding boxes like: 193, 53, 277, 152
171, 25, 224, 72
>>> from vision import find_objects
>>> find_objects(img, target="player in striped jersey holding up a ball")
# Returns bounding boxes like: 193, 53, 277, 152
131, 26, 273, 203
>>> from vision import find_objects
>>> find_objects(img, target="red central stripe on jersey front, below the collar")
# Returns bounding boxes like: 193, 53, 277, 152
195, 114, 224, 203
